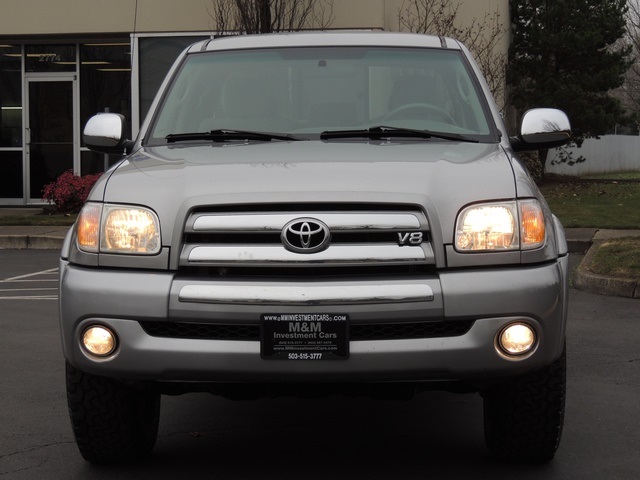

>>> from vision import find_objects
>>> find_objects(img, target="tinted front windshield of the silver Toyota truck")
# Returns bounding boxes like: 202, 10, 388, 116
147, 47, 497, 145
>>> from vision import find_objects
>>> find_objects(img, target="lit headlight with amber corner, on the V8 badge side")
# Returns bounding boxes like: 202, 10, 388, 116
455, 199, 545, 252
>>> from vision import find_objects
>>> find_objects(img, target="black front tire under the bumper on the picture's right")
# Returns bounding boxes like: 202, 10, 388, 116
482, 344, 566, 463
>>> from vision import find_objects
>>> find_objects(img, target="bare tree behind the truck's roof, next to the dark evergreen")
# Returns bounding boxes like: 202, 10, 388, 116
398, 0, 507, 110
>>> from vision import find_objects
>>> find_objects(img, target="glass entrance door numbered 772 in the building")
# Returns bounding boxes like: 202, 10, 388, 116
25, 76, 77, 203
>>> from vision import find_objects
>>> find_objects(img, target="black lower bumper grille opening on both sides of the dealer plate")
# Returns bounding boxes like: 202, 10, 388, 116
140, 320, 474, 342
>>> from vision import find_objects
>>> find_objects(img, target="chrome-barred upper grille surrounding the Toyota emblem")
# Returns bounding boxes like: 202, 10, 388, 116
180, 206, 435, 268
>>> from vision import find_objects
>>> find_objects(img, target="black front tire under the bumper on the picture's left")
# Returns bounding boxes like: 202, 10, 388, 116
66, 362, 160, 464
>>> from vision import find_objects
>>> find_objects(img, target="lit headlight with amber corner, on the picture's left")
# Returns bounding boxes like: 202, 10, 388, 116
77, 203, 161, 255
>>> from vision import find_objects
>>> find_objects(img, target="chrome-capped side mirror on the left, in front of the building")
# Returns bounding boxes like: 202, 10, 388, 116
82, 113, 131, 154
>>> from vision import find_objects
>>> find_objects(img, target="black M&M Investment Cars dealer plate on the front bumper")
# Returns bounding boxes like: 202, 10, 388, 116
260, 313, 349, 361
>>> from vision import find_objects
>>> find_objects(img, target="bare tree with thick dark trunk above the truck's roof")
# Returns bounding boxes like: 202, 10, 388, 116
209, 0, 334, 35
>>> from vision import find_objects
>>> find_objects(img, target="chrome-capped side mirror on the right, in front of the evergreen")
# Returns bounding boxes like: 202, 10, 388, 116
511, 108, 571, 152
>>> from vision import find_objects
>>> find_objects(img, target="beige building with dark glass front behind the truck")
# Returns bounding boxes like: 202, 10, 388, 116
0, 0, 509, 206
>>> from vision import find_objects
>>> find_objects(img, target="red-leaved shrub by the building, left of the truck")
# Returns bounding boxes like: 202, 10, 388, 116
42, 170, 102, 213
